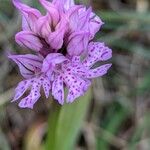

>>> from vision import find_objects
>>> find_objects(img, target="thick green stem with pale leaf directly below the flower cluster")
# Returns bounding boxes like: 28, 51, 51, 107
45, 90, 91, 150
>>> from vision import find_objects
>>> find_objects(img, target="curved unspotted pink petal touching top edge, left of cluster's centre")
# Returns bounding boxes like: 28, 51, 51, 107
39, 0, 60, 27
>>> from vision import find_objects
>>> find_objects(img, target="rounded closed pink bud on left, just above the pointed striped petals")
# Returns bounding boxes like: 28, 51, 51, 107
15, 31, 43, 51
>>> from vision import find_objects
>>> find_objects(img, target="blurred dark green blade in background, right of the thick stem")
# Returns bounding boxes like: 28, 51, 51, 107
97, 103, 129, 150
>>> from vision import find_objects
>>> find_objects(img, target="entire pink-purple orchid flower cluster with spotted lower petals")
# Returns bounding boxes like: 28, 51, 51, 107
9, 0, 112, 108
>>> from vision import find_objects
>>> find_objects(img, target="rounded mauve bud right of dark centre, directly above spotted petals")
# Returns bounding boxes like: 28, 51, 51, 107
67, 31, 89, 56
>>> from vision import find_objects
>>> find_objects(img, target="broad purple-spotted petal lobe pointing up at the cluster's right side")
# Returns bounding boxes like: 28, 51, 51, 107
83, 42, 112, 68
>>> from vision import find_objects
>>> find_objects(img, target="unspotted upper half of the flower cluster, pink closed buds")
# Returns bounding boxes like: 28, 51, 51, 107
13, 0, 103, 55
